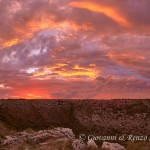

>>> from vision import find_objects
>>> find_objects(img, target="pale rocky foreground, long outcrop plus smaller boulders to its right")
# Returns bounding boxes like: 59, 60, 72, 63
0, 128, 125, 150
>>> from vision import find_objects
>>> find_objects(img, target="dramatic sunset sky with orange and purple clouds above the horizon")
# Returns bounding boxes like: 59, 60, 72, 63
0, 0, 150, 99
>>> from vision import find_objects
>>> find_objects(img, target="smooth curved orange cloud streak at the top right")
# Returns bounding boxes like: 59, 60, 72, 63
69, 2, 130, 27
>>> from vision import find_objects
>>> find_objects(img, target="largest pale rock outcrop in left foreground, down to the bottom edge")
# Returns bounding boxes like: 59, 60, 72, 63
0, 128, 75, 150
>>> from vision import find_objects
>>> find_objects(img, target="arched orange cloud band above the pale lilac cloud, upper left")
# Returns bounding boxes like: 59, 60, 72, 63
3, 18, 92, 48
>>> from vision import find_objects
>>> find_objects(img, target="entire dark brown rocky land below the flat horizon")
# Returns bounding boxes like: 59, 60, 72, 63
0, 100, 150, 150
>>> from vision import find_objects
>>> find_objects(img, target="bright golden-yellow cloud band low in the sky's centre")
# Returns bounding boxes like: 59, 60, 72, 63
33, 64, 98, 80
